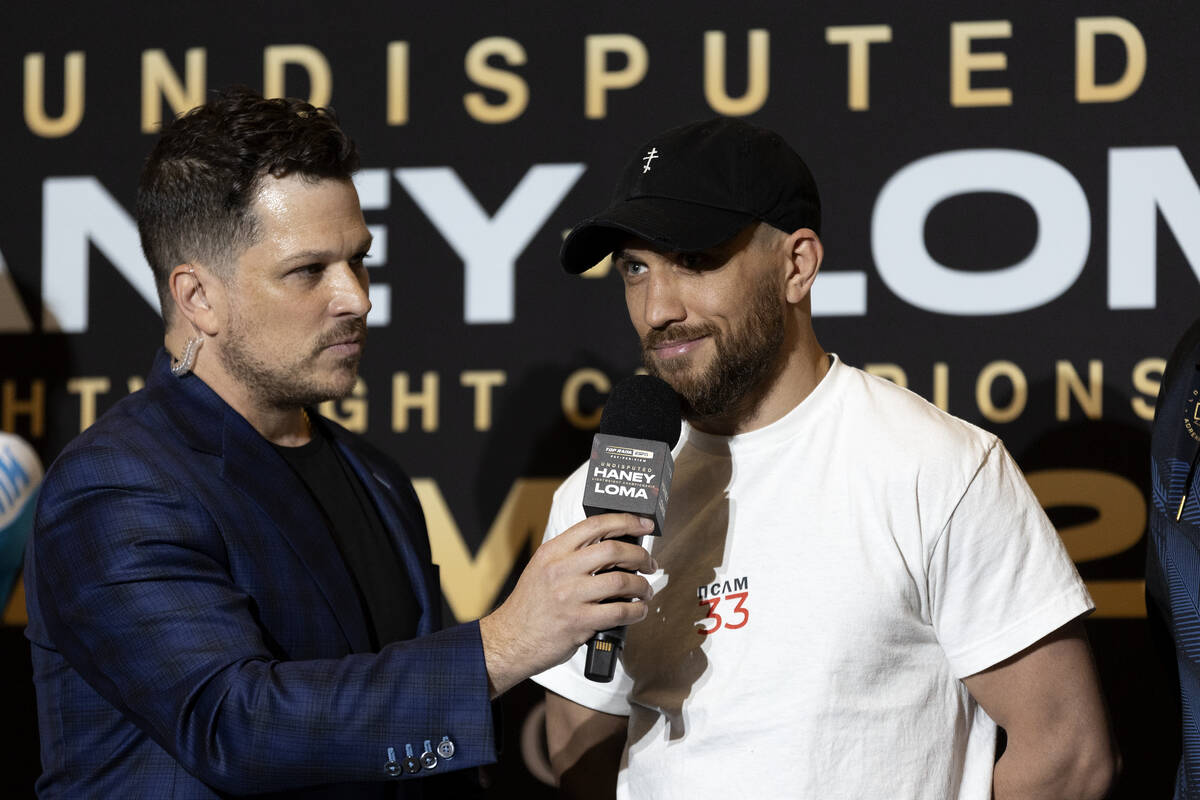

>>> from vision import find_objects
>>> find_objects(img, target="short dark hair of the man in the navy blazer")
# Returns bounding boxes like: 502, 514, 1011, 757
137, 86, 359, 323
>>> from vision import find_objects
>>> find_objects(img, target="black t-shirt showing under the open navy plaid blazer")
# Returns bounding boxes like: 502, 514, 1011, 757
275, 421, 420, 650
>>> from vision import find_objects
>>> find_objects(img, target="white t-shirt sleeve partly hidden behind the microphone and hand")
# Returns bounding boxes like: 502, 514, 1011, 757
533, 464, 634, 716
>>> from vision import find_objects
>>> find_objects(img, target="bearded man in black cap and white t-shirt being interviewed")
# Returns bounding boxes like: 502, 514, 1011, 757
534, 119, 1117, 800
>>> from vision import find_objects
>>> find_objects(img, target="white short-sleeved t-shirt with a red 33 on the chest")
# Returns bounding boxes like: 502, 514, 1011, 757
534, 356, 1092, 800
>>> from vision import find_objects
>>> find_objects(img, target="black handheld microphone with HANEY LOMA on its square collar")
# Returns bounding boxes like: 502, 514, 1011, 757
583, 375, 680, 682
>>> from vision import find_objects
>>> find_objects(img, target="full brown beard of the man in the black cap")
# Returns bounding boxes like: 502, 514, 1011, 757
642, 272, 785, 421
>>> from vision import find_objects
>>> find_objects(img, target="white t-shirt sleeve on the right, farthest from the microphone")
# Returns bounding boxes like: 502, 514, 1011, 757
928, 440, 1094, 678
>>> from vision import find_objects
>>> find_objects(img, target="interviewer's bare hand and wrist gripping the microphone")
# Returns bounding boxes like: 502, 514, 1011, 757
479, 513, 658, 697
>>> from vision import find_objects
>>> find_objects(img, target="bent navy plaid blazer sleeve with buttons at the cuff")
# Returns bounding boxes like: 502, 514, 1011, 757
28, 444, 496, 794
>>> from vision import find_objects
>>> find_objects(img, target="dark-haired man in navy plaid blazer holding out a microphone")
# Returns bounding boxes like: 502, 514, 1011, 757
25, 84, 652, 798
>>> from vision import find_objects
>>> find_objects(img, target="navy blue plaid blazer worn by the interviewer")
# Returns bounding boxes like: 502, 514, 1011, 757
25, 350, 496, 798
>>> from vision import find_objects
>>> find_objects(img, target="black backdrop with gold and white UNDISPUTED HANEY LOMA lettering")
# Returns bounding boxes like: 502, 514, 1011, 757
0, 0, 1200, 798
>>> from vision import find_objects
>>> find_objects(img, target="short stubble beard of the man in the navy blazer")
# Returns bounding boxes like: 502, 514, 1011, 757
218, 317, 367, 409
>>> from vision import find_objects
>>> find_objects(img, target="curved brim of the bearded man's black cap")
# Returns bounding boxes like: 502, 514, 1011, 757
558, 197, 755, 275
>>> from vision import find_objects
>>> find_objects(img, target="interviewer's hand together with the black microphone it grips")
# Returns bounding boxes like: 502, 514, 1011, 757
479, 375, 679, 697
